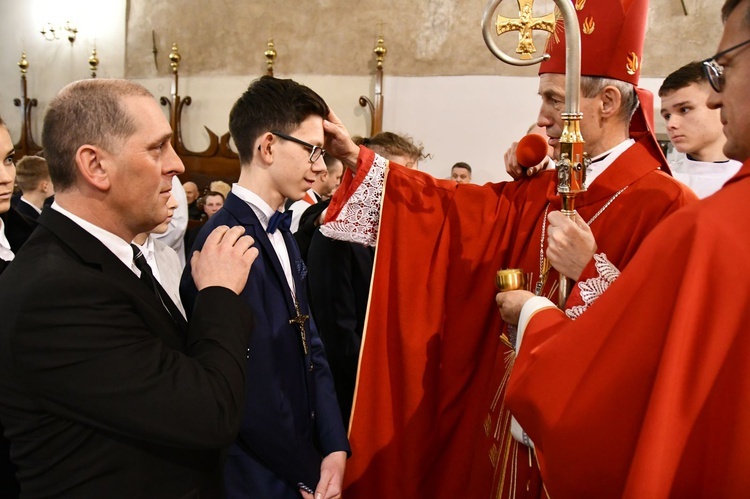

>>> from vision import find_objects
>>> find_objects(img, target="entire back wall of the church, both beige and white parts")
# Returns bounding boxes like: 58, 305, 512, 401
0, 0, 721, 183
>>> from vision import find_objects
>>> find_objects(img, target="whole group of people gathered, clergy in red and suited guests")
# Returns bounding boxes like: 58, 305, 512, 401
0, 0, 750, 499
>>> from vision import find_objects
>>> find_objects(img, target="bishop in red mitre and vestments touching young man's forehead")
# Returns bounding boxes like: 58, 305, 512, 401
321, 0, 696, 499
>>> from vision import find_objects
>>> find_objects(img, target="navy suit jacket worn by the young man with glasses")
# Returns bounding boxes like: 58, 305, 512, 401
180, 194, 349, 499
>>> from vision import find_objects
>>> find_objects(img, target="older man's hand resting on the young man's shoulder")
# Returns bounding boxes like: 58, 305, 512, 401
190, 225, 258, 294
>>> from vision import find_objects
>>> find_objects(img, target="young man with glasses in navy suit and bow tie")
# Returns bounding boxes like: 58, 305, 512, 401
180, 76, 349, 499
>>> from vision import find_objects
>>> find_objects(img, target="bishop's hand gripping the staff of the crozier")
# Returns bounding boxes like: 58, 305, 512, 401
547, 211, 597, 281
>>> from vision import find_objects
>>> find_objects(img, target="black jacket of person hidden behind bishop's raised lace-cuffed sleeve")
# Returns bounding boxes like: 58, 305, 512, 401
307, 230, 375, 427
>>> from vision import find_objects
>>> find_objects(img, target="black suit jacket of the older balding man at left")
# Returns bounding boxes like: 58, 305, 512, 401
0, 209, 251, 498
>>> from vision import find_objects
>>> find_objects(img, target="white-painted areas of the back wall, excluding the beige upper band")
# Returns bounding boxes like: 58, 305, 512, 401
0, 0, 664, 188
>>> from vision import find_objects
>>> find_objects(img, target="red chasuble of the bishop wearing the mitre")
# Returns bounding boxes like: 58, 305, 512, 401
328, 142, 696, 499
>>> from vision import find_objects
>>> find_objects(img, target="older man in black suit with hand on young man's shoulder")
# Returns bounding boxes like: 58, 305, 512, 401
0, 80, 257, 498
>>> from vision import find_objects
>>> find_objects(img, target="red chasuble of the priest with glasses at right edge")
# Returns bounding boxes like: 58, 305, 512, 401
507, 161, 750, 498
